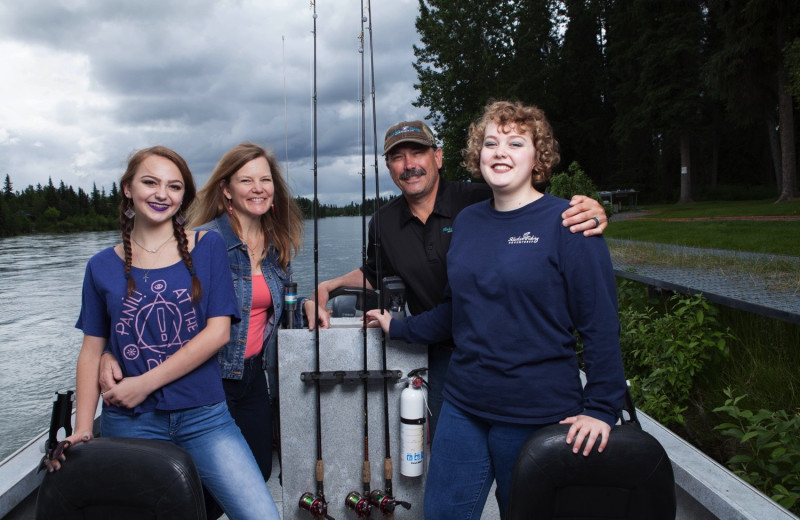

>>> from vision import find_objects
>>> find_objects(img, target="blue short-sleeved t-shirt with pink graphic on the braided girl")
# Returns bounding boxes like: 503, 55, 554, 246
75, 233, 239, 414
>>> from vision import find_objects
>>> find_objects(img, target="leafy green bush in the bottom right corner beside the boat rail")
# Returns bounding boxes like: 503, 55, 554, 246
714, 388, 800, 513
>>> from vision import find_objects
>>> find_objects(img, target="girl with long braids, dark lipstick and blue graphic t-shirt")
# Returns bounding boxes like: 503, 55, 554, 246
49, 146, 280, 519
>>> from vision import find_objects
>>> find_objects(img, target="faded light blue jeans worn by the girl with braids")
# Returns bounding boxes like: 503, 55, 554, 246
100, 402, 280, 520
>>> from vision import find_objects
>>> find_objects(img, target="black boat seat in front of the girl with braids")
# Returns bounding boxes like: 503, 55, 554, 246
36, 438, 206, 520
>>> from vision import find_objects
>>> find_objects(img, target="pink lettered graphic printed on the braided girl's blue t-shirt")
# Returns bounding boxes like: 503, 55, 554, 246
114, 280, 198, 370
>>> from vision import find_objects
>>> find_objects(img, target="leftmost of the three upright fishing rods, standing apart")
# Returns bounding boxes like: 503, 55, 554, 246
298, 0, 334, 520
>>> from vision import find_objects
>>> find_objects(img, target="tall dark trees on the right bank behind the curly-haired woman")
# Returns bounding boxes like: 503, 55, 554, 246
414, 0, 800, 202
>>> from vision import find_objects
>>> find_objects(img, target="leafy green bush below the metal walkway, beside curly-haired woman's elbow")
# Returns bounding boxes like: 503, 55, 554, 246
618, 280, 733, 426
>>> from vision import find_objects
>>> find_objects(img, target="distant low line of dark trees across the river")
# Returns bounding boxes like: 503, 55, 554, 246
0, 175, 389, 237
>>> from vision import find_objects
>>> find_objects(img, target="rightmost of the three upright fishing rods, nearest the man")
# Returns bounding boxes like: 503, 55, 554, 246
362, 0, 411, 518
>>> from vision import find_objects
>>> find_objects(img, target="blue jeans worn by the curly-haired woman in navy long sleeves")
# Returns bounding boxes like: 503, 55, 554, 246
424, 400, 544, 520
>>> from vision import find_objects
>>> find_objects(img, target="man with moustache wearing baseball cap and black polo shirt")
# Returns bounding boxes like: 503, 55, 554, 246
312, 121, 608, 440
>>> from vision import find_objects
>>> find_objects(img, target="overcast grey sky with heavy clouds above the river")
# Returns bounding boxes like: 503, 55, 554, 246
0, 0, 427, 204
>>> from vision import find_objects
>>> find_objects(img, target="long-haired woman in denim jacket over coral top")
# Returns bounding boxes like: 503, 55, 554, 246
100, 143, 325, 490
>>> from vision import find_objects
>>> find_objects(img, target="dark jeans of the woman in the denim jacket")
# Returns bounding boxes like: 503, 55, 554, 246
222, 356, 272, 480
